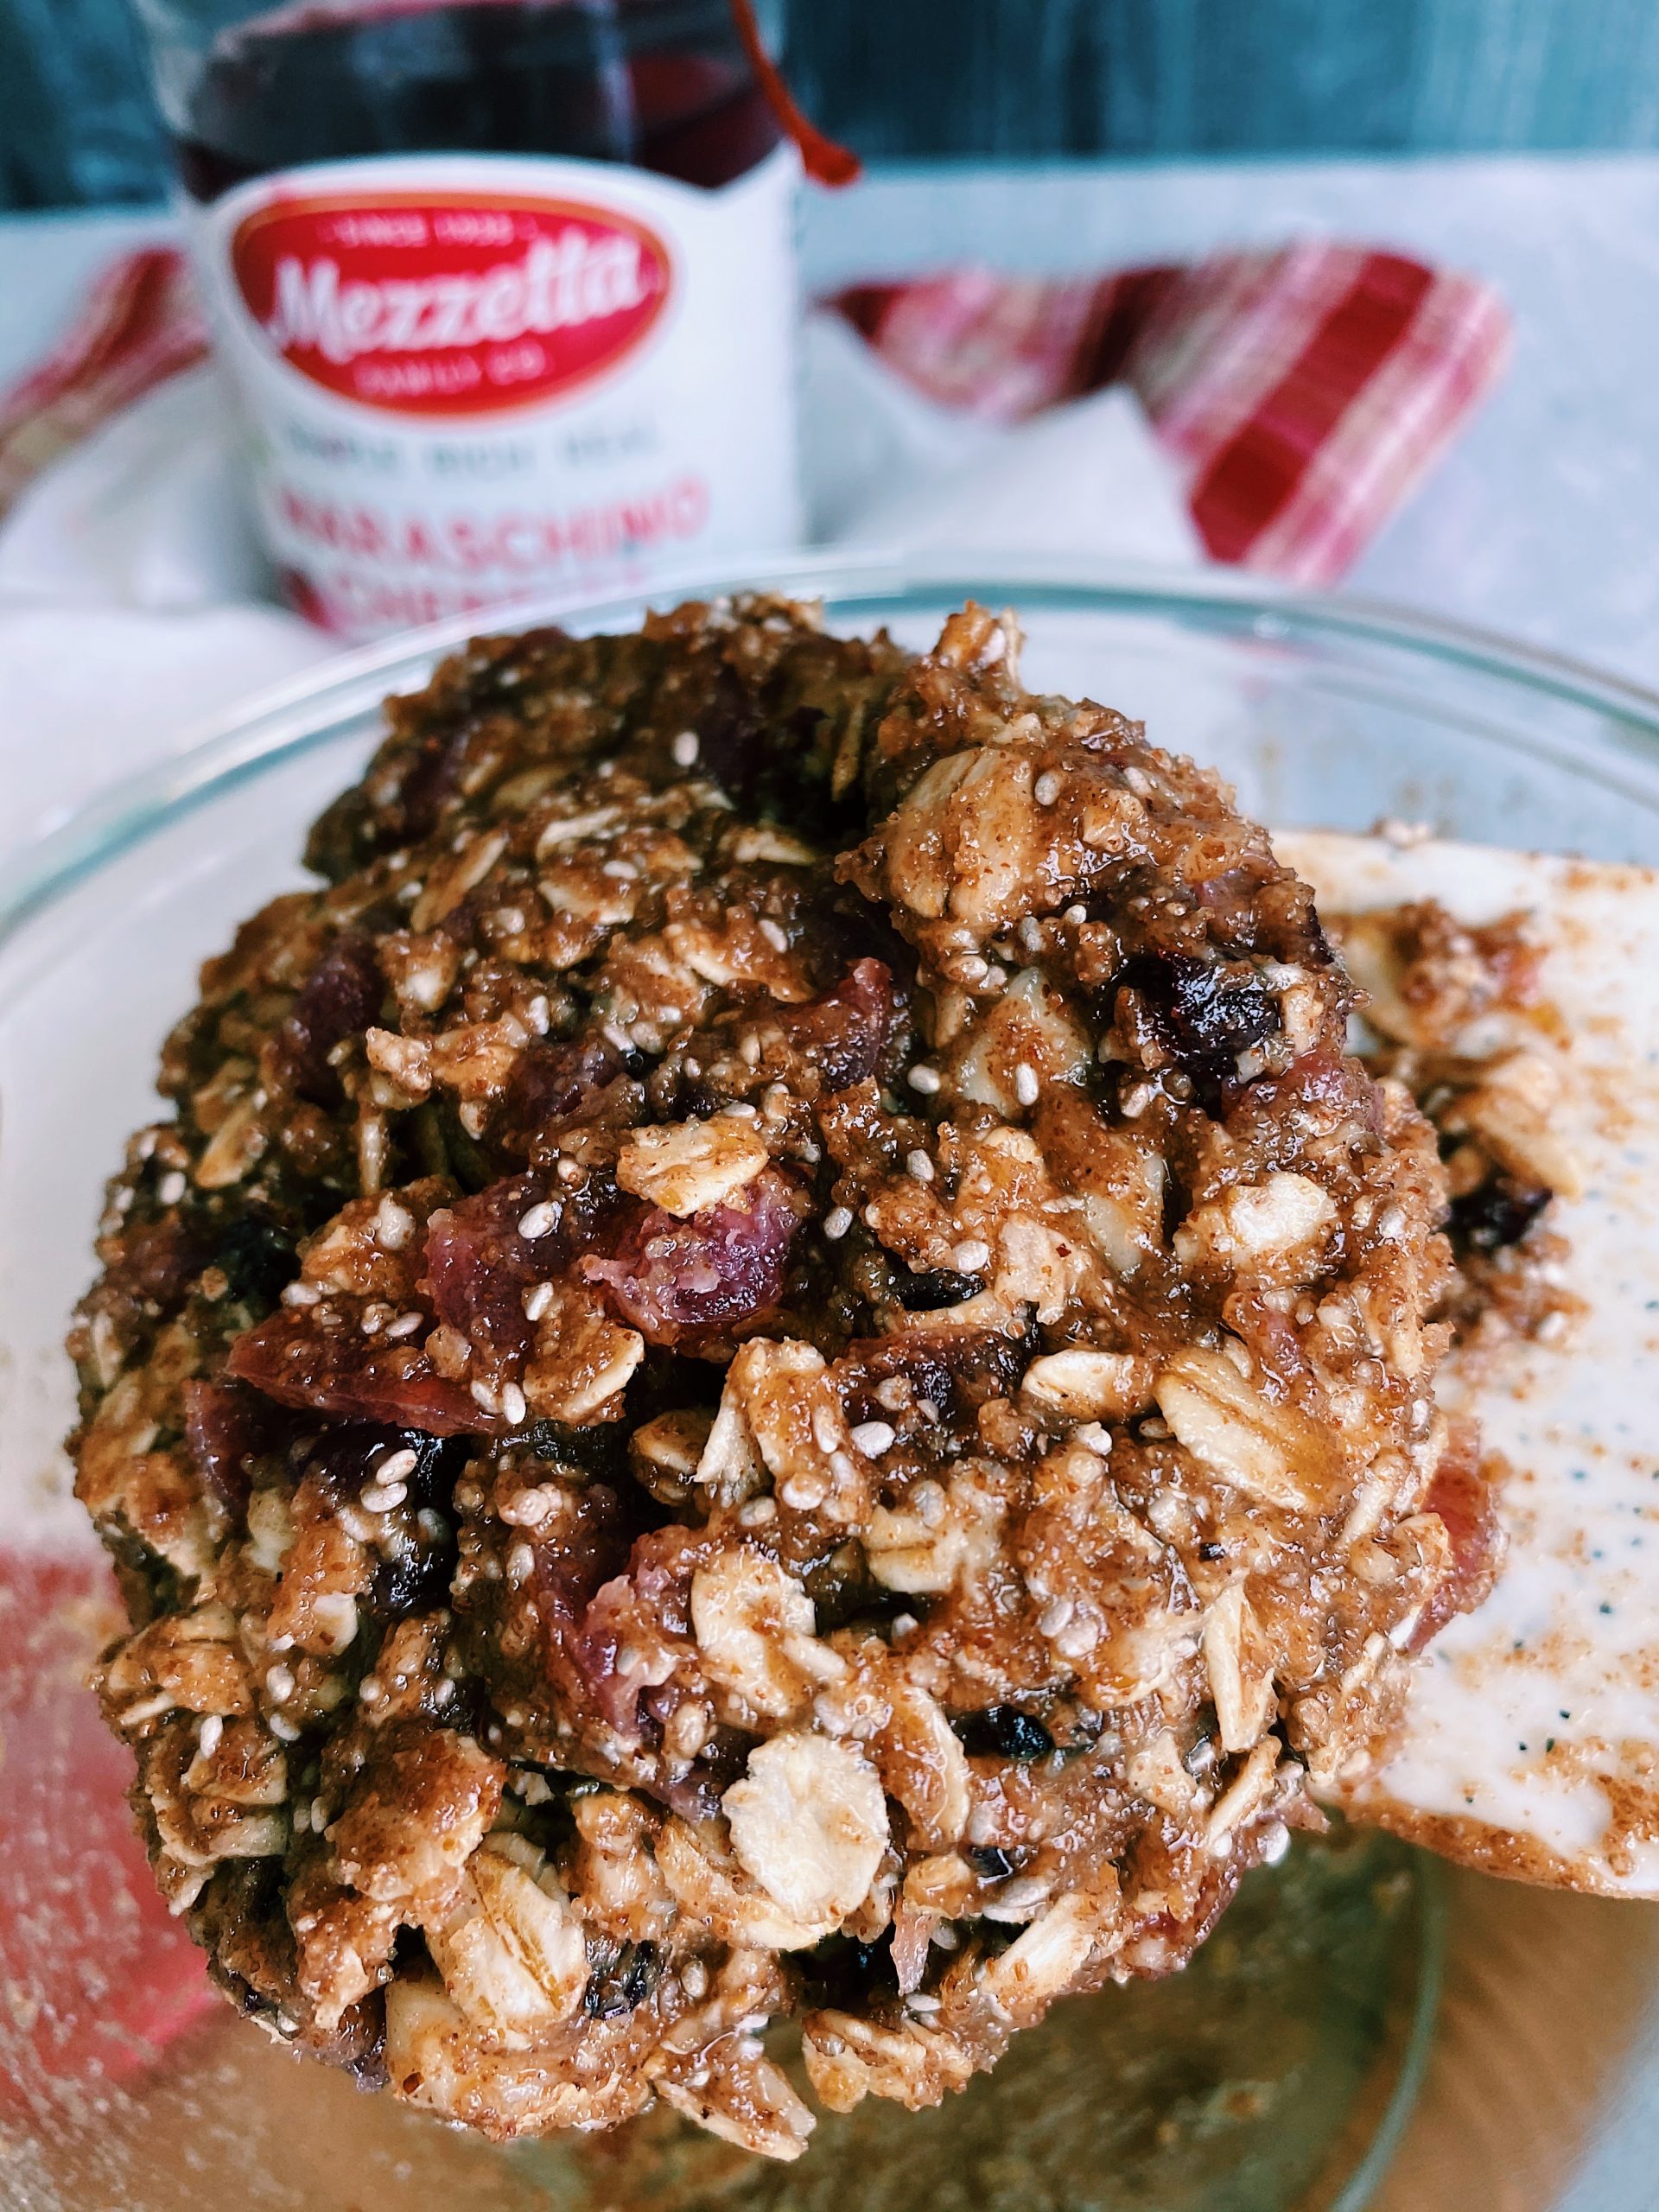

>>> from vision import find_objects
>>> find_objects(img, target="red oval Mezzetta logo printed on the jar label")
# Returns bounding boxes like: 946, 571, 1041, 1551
230, 193, 672, 416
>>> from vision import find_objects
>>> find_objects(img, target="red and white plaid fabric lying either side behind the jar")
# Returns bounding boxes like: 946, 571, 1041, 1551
0, 241, 1509, 584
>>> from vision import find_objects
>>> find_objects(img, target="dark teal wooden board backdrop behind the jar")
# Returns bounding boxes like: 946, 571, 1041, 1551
0, 0, 1659, 206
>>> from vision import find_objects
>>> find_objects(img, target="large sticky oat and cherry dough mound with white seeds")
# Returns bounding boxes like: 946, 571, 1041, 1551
75, 600, 1491, 2157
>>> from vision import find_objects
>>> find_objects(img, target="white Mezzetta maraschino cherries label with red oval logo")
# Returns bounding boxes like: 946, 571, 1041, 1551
194, 150, 798, 637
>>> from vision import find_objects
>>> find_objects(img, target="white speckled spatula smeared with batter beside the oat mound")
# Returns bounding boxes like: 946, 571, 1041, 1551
1274, 832, 1659, 1897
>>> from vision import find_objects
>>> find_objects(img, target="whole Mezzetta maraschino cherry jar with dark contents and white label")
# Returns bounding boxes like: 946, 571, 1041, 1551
143, 0, 798, 637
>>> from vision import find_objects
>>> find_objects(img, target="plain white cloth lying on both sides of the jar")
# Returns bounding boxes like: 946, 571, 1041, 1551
0, 315, 1201, 856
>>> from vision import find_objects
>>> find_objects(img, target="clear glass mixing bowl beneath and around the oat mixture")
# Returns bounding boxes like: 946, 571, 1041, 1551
0, 560, 1659, 2212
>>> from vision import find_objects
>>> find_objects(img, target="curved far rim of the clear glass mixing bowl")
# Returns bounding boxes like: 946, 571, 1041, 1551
0, 549, 1659, 949
